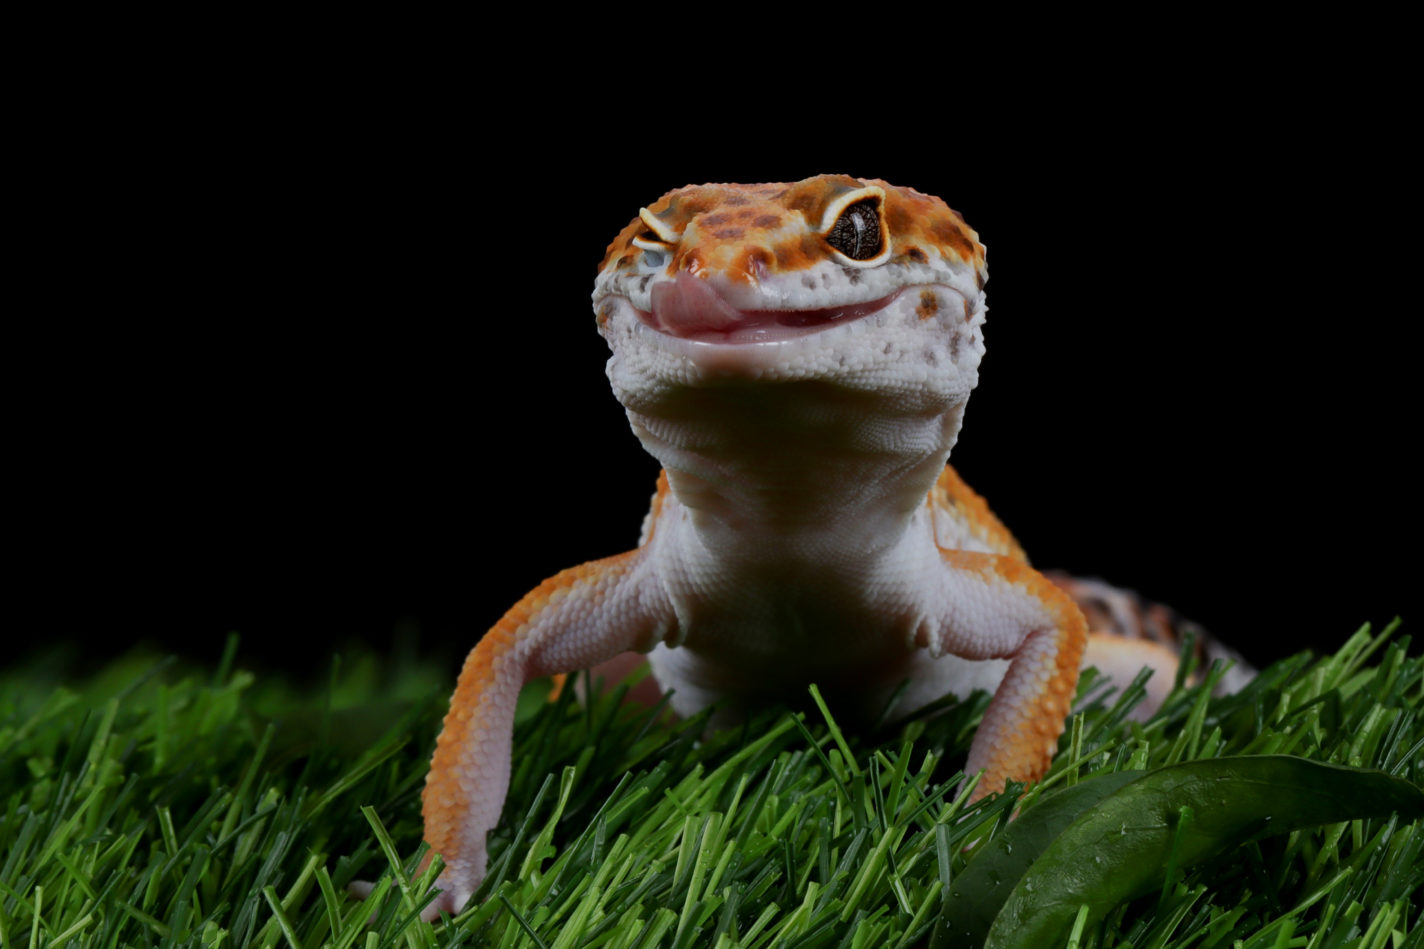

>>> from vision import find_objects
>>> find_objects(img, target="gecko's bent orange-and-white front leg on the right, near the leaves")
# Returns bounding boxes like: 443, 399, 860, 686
920, 549, 1088, 799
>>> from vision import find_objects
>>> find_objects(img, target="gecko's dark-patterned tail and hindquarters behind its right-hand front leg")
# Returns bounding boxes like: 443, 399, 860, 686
1044, 571, 1256, 695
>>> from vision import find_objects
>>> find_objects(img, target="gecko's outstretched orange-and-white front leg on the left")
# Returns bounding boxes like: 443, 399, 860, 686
363, 547, 674, 921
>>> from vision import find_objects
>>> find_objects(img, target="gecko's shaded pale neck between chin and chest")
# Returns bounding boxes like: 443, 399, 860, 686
628, 382, 967, 556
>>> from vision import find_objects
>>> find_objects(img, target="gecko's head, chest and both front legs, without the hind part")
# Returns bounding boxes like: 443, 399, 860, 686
381, 175, 1236, 918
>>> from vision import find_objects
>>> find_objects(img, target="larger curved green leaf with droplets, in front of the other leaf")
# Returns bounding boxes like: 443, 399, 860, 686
984, 755, 1424, 949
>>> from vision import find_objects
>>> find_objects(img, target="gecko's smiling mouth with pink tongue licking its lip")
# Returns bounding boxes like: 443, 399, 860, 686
635, 272, 900, 343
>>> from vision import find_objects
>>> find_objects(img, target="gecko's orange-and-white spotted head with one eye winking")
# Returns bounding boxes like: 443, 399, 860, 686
594, 175, 985, 412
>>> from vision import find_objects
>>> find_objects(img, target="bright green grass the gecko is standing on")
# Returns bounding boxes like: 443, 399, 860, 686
0, 630, 1424, 949
